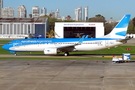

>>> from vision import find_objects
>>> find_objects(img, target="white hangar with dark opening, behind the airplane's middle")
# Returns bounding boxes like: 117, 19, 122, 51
55, 22, 104, 38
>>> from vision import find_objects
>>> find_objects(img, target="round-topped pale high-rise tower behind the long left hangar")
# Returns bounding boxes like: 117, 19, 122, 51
18, 5, 27, 18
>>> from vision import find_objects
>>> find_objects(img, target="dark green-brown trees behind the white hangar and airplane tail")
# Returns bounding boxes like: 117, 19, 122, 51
41, 14, 135, 35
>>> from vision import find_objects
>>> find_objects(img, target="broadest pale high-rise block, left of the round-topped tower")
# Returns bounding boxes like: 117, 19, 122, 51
2, 7, 14, 18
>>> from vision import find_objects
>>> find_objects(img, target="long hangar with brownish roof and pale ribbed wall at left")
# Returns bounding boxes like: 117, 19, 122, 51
0, 18, 48, 38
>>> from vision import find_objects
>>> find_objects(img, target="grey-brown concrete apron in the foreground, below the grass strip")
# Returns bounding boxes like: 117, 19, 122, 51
0, 59, 135, 90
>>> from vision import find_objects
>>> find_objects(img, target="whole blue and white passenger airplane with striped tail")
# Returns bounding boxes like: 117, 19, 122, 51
2, 14, 131, 56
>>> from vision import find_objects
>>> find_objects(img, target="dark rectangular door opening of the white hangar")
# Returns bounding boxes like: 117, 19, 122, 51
64, 27, 96, 38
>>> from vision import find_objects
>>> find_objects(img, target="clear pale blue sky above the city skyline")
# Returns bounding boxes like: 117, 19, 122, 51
3, 0, 135, 21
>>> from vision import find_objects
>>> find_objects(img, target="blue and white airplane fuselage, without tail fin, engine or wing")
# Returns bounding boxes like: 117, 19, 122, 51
2, 38, 123, 53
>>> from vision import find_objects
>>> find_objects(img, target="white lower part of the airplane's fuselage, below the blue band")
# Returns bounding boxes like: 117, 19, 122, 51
9, 40, 123, 51
